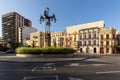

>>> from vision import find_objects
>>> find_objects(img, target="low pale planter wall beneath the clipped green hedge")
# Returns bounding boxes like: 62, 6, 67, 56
16, 54, 72, 58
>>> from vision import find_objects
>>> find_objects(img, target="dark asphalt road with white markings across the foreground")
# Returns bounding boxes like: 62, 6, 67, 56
0, 56, 120, 80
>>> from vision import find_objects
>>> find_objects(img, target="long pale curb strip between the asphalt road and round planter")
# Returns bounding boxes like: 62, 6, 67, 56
0, 58, 87, 63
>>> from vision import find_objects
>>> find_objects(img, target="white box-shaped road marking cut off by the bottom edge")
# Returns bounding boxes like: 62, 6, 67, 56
23, 75, 59, 80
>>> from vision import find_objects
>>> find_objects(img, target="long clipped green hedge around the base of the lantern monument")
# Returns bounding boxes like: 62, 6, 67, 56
16, 47, 74, 54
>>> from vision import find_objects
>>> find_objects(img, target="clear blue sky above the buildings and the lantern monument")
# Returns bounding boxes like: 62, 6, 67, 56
0, 0, 120, 36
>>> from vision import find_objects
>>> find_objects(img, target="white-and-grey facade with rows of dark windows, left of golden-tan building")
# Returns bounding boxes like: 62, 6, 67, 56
78, 27, 100, 53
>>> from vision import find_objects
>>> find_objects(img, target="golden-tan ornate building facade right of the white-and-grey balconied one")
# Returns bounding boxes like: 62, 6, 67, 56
99, 27, 116, 54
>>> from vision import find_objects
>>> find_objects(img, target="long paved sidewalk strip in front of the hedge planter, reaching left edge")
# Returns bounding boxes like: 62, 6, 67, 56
0, 54, 87, 62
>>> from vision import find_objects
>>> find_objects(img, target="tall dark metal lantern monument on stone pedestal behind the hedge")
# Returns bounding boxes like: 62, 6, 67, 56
40, 8, 56, 47
